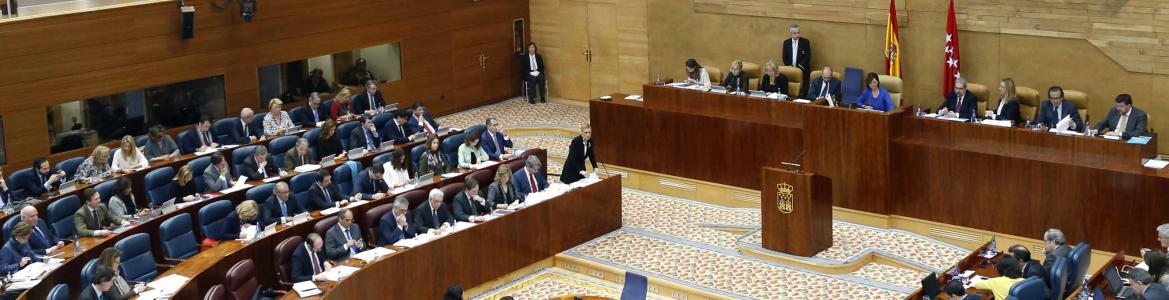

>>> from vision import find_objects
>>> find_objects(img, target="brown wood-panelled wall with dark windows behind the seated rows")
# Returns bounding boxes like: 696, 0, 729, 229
0, 0, 528, 167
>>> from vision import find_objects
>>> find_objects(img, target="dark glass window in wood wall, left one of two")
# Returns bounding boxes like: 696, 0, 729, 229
46, 76, 224, 153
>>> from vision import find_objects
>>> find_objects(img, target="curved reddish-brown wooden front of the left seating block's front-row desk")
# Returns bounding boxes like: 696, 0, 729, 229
277, 176, 621, 299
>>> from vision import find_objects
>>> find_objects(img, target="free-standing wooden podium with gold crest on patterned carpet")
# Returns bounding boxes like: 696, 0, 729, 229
760, 167, 832, 257
